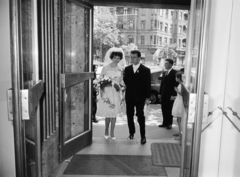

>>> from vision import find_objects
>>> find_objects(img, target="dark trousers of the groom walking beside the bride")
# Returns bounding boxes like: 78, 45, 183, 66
126, 100, 145, 138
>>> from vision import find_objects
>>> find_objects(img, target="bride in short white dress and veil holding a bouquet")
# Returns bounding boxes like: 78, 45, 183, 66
97, 49, 126, 139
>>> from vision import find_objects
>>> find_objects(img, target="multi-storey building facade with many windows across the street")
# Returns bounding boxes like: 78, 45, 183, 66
110, 7, 189, 62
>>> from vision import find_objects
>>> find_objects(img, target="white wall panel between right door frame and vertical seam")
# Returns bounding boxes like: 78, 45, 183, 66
199, 0, 232, 177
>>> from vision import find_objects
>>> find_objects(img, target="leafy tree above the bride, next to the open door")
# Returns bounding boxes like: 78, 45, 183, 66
93, 7, 124, 59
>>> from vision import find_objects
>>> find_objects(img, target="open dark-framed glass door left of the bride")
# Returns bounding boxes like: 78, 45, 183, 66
59, 0, 93, 161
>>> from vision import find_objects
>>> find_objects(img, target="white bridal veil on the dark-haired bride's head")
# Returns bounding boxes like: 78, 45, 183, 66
104, 47, 127, 68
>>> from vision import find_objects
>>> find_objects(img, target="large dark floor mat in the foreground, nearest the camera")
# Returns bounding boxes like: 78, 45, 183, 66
64, 154, 167, 176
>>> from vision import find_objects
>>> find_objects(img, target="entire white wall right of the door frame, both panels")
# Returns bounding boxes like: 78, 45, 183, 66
199, 0, 240, 177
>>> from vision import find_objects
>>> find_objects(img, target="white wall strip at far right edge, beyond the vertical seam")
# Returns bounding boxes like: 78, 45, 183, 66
219, 0, 240, 177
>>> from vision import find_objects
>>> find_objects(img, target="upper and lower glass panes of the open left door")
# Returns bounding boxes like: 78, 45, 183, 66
64, 2, 90, 141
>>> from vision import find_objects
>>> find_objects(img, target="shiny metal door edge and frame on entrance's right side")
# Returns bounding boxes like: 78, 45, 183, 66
180, 0, 211, 177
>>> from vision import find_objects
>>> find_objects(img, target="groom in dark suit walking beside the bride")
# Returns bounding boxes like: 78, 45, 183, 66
123, 50, 151, 144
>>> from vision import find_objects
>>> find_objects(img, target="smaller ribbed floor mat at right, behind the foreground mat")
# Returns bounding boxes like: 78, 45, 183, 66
151, 143, 190, 167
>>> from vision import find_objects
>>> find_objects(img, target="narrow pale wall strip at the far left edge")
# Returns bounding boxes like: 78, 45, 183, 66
0, 0, 16, 177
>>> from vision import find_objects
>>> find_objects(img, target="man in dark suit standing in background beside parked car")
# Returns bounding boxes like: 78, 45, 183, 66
158, 59, 178, 129
